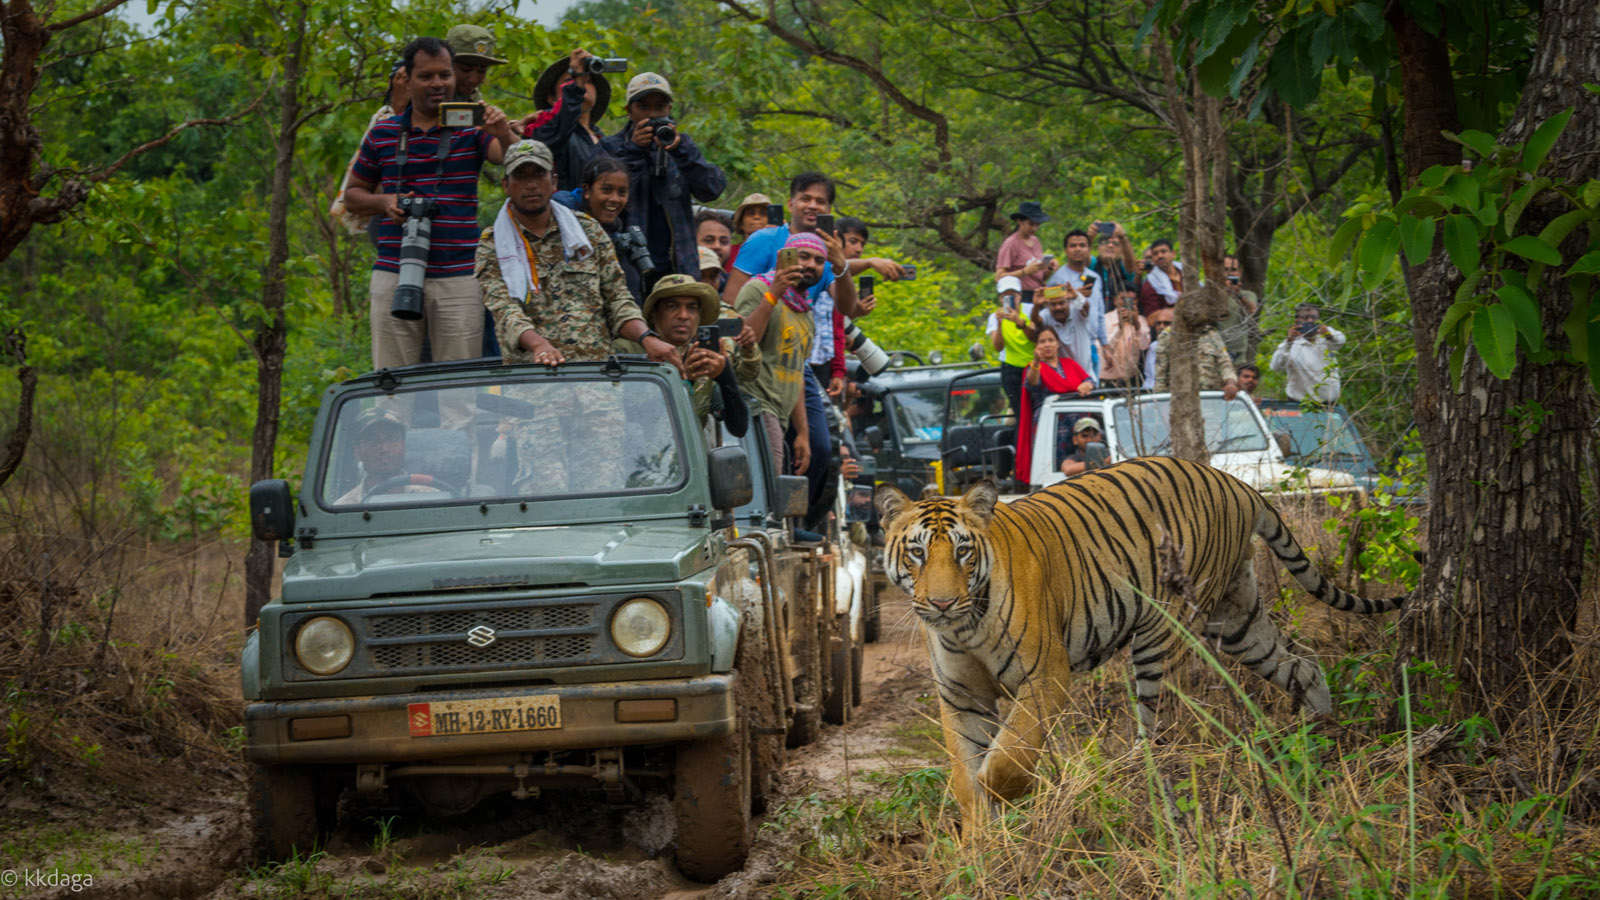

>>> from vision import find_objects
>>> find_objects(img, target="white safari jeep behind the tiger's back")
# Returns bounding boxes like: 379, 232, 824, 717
1014, 391, 1360, 493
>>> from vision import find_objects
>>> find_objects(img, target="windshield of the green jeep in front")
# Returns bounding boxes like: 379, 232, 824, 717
318, 375, 688, 511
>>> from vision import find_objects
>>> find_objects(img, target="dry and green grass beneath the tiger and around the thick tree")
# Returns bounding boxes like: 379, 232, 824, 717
782, 499, 1600, 900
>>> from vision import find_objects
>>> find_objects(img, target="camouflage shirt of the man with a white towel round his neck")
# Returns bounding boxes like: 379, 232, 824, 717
474, 213, 645, 365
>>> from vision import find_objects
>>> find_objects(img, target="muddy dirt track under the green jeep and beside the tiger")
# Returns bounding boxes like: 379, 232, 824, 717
15, 594, 938, 900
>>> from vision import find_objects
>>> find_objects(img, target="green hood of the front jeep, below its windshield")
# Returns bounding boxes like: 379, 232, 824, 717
282, 522, 710, 604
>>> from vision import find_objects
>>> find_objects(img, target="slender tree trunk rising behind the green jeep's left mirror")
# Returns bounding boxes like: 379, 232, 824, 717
245, 0, 306, 628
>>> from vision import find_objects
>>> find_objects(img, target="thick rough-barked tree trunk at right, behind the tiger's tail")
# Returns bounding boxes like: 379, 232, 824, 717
1390, 0, 1600, 717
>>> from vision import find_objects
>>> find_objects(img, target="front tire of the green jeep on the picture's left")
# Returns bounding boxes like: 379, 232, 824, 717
250, 764, 339, 865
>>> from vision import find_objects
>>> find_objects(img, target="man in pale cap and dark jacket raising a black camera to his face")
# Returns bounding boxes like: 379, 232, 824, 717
605, 72, 728, 288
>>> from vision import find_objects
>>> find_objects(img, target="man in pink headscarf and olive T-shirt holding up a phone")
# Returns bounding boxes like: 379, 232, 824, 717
734, 232, 856, 474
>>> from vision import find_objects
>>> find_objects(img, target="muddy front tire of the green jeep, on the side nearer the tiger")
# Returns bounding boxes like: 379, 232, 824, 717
672, 682, 752, 884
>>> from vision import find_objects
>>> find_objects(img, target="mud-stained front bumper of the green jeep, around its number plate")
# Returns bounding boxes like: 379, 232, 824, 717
245, 674, 736, 764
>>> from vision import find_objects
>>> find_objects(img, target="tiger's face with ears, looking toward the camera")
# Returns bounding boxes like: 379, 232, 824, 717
872, 479, 1000, 626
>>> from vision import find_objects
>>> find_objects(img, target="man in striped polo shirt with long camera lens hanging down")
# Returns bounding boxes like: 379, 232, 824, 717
344, 37, 514, 368
